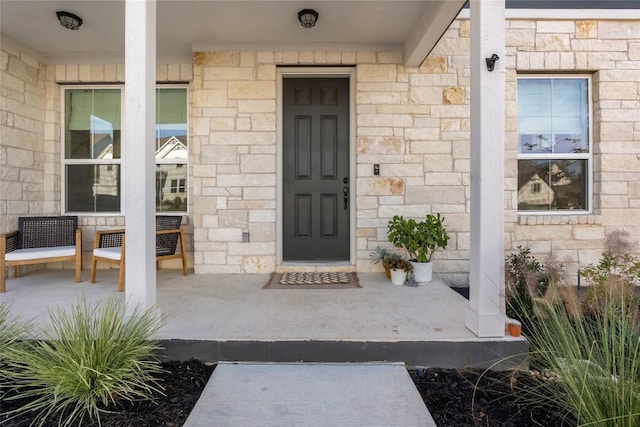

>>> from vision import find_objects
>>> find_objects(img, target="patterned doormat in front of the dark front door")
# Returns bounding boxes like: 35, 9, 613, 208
264, 271, 361, 289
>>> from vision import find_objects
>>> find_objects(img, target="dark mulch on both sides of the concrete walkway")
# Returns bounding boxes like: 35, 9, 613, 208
0, 360, 576, 427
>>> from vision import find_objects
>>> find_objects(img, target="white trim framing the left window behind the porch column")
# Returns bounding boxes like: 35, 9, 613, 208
60, 83, 191, 217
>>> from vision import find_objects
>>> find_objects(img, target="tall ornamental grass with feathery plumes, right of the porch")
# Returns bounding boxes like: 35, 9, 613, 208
511, 234, 640, 427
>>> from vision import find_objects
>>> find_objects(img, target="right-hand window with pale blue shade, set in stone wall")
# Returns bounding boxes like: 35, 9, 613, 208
517, 75, 593, 213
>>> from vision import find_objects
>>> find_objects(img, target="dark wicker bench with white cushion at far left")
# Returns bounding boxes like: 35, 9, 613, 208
0, 216, 82, 293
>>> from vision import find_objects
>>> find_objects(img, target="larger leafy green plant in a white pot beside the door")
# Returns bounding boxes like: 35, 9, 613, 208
387, 213, 449, 283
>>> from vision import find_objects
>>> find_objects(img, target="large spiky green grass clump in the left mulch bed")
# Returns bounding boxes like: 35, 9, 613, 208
5, 299, 162, 426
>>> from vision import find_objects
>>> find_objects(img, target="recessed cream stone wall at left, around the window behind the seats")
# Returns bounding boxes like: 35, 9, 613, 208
0, 42, 193, 268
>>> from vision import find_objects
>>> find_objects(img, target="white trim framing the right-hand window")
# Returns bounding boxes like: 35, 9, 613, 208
516, 73, 595, 216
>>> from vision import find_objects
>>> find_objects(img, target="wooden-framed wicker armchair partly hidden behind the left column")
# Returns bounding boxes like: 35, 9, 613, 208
90, 216, 187, 292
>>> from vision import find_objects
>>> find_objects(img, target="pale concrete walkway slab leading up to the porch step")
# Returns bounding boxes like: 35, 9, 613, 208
184, 363, 436, 427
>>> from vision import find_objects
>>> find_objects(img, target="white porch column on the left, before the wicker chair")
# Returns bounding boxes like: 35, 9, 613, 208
122, 0, 156, 312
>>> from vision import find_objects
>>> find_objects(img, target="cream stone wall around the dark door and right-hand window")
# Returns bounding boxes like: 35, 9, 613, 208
191, 19, 640, 285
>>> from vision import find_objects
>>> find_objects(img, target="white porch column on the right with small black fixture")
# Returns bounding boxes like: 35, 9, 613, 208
465, 0, 505, 337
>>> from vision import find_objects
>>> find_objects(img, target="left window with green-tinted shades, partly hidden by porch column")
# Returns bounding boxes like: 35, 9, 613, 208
63, 86, 188, 213
